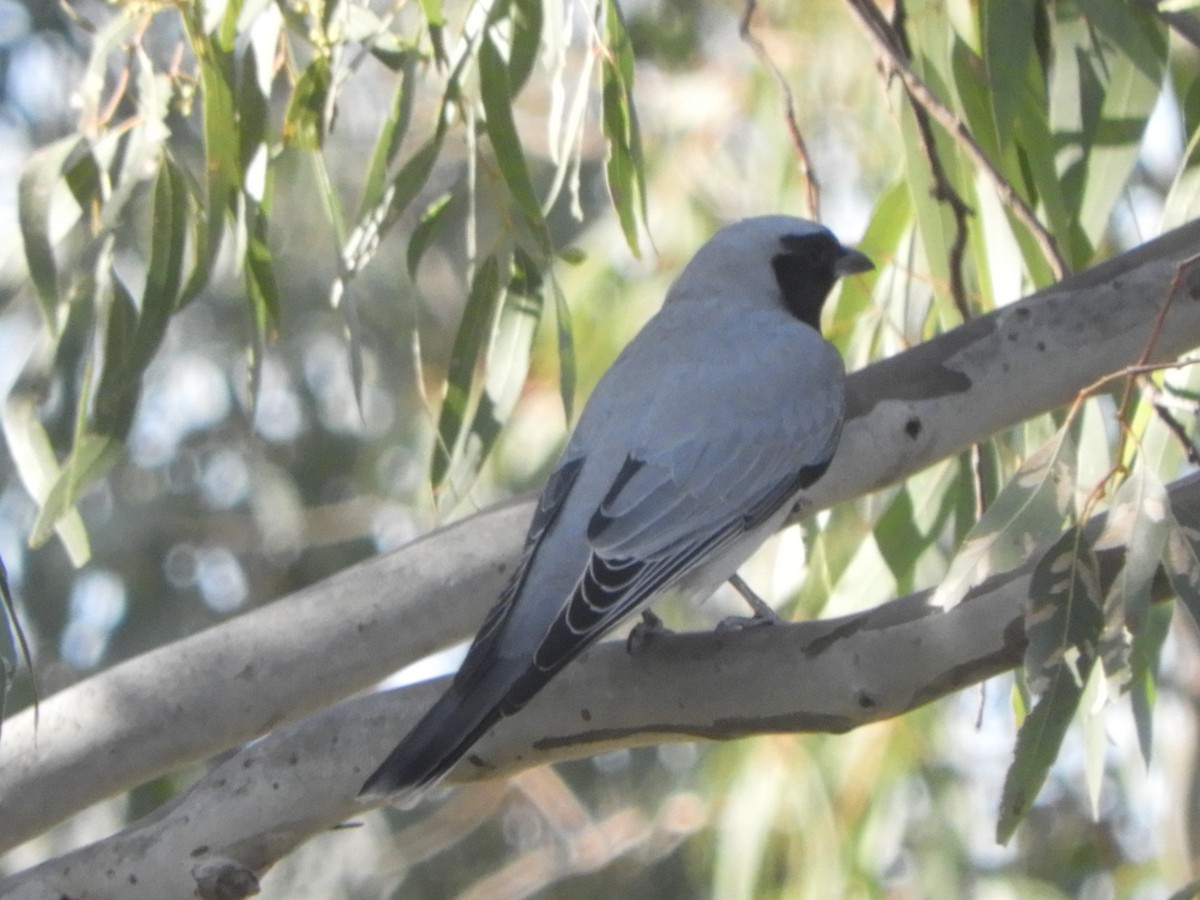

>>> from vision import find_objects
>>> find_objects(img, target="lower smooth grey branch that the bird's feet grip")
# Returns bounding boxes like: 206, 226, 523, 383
0, 474, 1200, 900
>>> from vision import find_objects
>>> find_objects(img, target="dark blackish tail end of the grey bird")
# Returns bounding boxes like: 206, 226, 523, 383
359, 679, 508, 802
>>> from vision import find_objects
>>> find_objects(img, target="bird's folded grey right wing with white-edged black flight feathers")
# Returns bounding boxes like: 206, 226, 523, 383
505, 331, 845, 712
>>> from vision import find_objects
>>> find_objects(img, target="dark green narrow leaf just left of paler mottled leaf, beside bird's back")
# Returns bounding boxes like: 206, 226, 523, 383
430, 256, 503, 494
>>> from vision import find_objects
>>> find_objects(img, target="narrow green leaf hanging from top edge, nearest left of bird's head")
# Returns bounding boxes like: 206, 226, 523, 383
600, 0, 646, 257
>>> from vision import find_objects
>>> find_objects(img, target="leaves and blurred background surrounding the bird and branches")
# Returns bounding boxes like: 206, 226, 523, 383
0, 0, 1200, 899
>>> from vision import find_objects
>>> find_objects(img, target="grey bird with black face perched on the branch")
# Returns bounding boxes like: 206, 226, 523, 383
361, 215, 874, 805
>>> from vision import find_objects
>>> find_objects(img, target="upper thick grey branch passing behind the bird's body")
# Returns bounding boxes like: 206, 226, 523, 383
7, 222, 1200, 848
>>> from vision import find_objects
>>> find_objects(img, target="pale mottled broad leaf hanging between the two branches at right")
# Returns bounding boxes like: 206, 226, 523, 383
930, 428, 1075, 610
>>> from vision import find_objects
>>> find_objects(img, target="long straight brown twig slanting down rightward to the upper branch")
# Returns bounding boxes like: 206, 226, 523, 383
846, 0, 1068, 281
